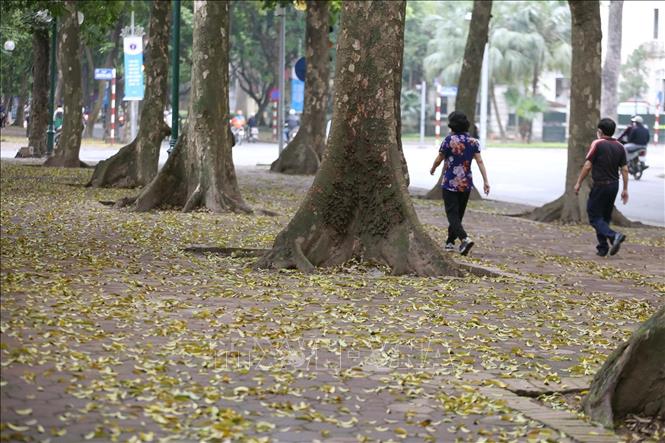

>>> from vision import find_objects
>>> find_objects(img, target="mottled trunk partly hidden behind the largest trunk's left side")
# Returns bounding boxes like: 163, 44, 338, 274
270, 0, 330, 174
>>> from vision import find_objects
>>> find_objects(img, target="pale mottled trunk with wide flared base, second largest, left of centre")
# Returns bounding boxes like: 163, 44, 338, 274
120, 1, 250, 212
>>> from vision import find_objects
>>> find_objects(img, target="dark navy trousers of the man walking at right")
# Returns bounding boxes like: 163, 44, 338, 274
587, 181, 619, 254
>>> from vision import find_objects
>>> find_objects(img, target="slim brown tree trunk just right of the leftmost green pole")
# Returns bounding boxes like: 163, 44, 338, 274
44, 0, 83, 168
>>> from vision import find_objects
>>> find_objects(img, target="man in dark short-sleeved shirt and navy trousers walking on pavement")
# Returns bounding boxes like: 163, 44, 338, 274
575, 118, 628, 257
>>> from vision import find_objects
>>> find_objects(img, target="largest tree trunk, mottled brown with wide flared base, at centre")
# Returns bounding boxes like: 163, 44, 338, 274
256, 1, 459, 275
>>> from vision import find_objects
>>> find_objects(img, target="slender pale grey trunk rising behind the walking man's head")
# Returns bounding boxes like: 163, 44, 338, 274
601, 0, 623, 121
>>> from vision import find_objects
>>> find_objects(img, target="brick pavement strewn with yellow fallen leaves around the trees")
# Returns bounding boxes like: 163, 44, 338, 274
0, 163, 665, 442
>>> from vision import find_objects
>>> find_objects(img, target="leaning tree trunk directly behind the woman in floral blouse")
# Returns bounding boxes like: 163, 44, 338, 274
425, 0, 492, 200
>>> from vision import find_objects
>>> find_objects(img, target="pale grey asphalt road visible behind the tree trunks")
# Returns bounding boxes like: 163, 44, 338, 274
0, 142, 665, 226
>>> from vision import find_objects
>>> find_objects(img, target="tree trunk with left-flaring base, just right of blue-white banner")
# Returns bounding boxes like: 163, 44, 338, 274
89, 0, 171, 188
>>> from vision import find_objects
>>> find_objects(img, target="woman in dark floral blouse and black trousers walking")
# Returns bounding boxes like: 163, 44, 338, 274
429, 111, 490, 255
